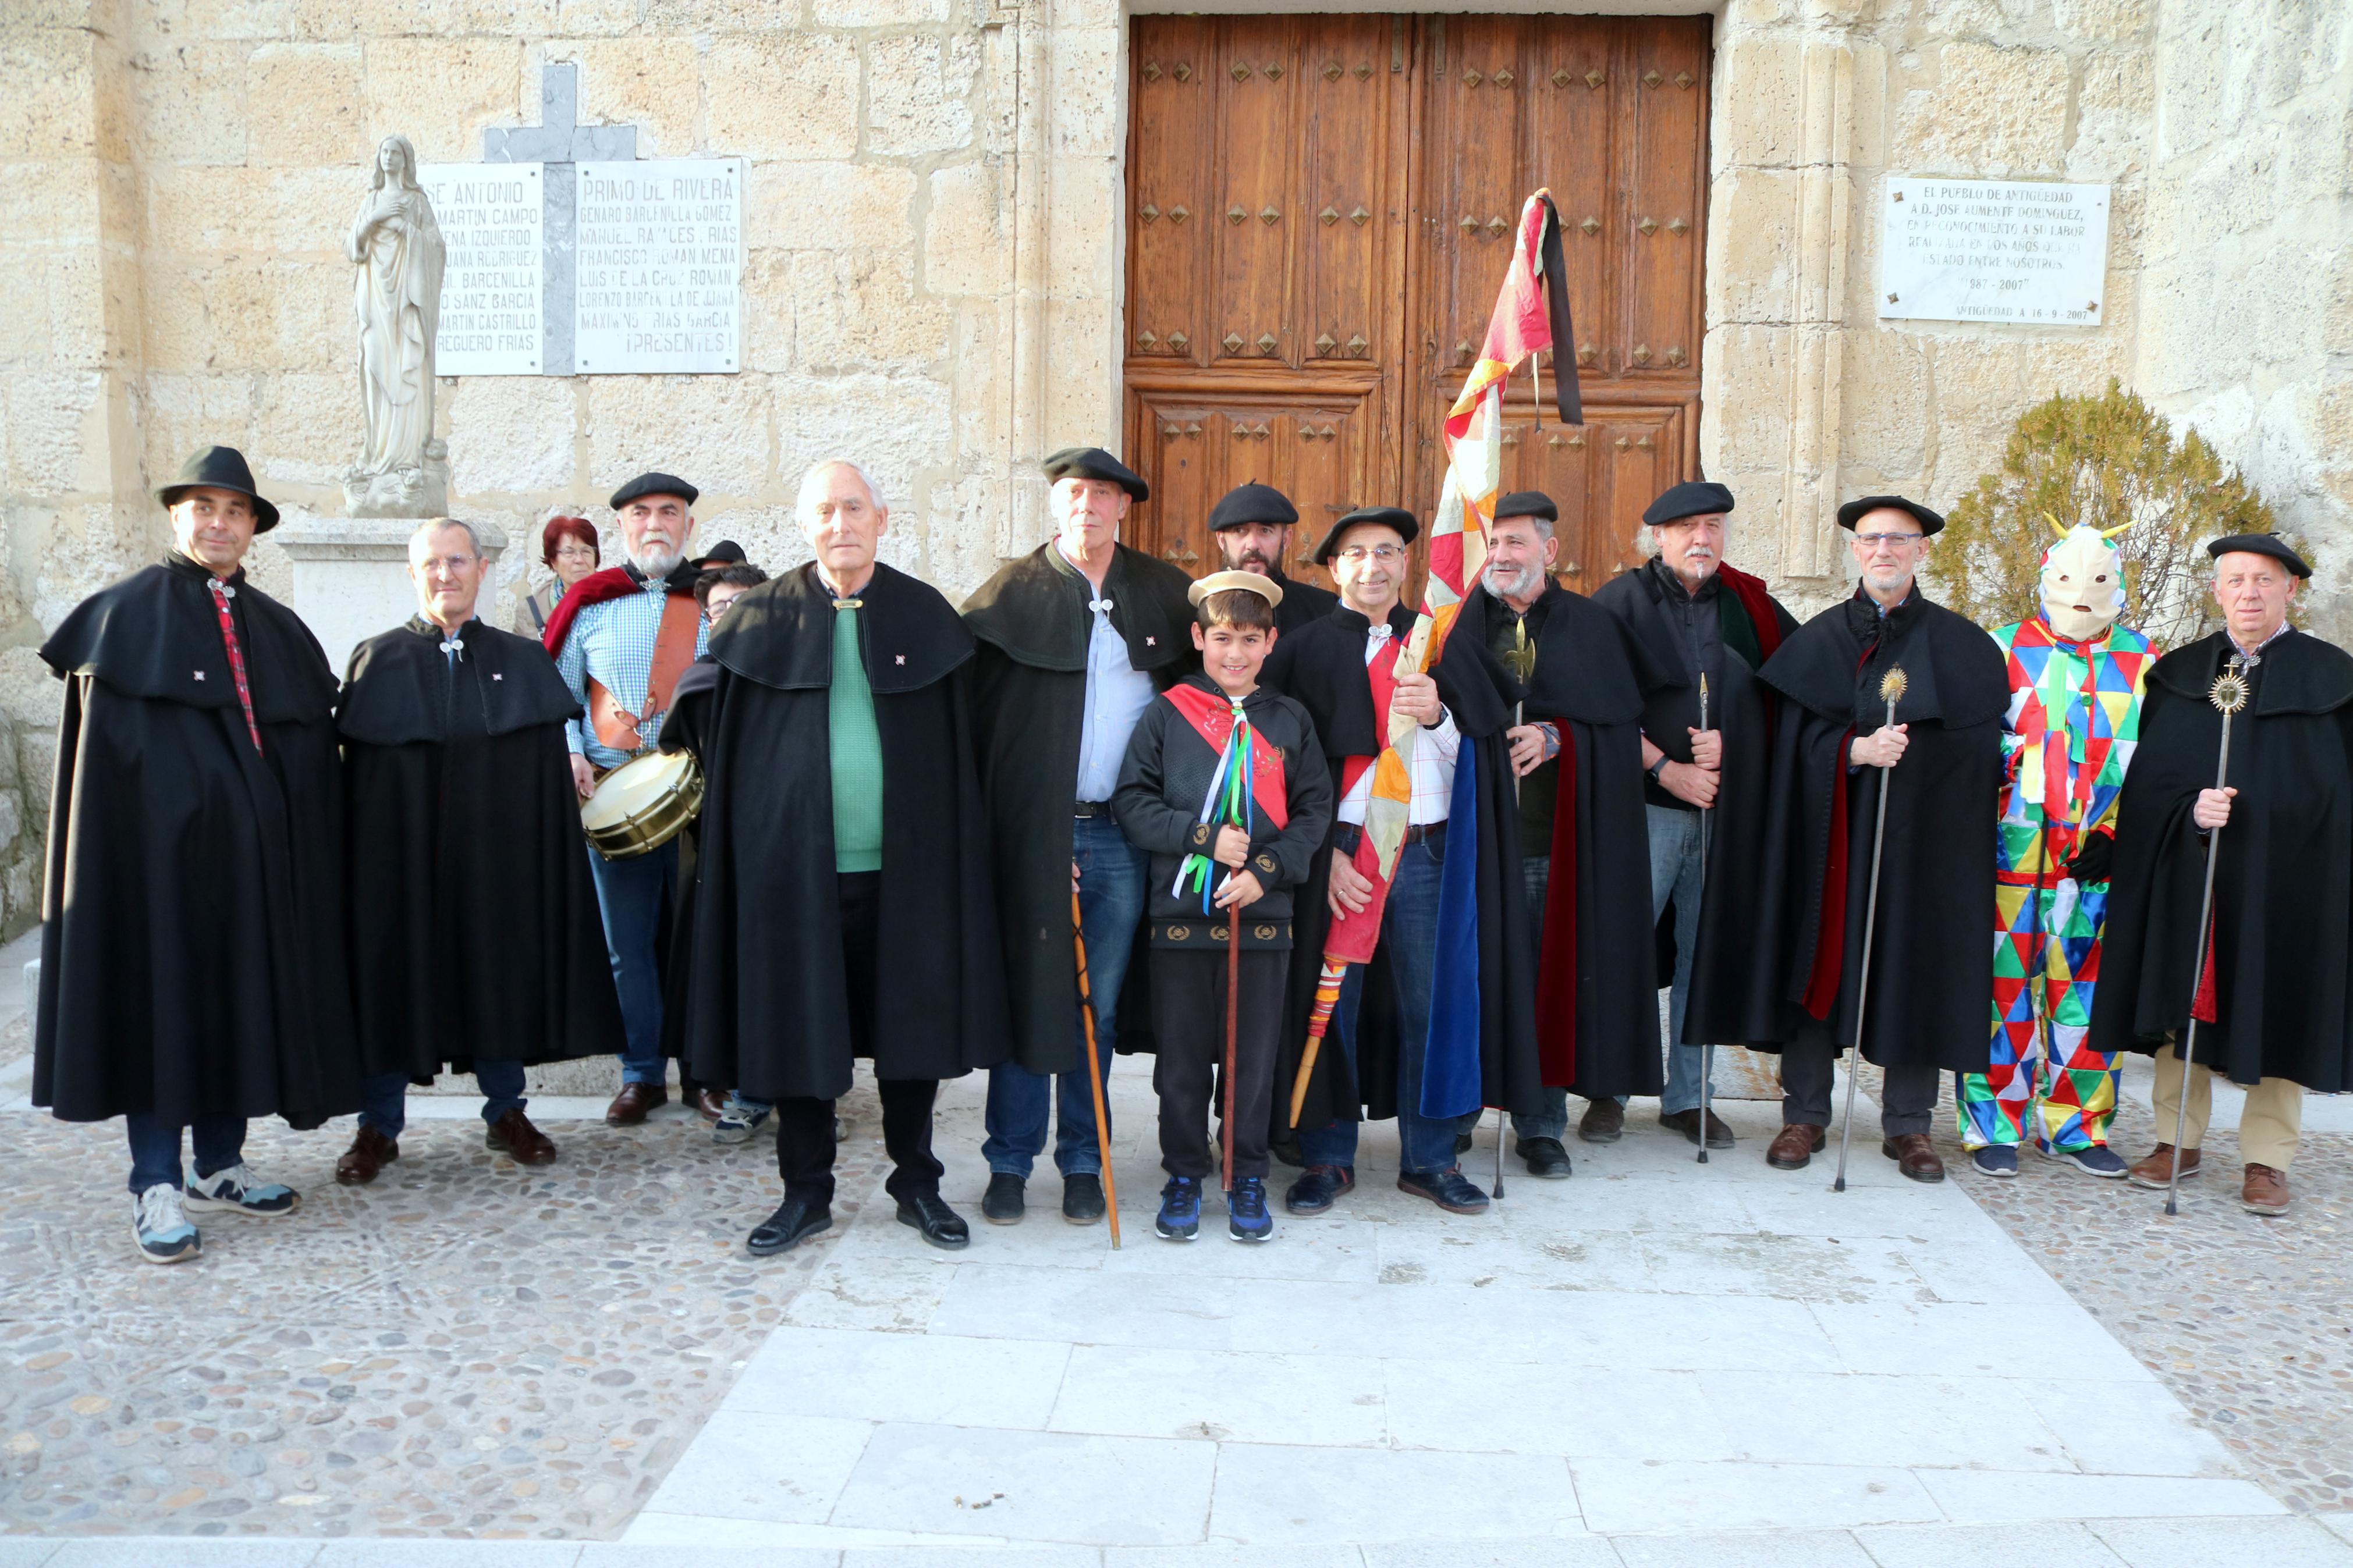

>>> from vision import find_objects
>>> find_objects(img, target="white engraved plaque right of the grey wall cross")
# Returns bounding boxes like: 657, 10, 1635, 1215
572, 158, 744, 376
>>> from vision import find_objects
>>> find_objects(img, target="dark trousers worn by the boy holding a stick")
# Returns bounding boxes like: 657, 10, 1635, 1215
1151, 947, 1292, 1180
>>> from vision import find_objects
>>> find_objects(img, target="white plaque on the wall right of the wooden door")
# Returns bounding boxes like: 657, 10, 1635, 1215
1880, 179, 2109, 327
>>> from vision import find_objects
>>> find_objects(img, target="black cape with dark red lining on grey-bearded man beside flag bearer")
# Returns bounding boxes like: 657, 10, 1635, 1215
1447, 583, 1676, 1100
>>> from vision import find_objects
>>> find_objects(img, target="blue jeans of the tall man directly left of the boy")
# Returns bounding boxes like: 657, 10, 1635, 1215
981, 816, 1151, 1180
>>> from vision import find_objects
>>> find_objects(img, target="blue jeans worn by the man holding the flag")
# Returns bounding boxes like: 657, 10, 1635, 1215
1299, 834, 1478, 1175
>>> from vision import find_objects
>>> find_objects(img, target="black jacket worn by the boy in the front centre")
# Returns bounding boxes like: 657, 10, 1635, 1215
1110, 675, 1334, 950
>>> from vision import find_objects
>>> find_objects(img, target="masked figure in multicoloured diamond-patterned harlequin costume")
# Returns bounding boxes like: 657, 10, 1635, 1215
1953, 524, 2155, 1178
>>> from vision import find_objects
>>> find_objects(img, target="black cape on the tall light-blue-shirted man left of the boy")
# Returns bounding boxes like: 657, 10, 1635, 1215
960, 538, 1200, 1072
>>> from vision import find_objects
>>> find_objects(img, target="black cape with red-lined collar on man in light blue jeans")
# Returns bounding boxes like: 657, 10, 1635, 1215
1593, 557, 1797, 1046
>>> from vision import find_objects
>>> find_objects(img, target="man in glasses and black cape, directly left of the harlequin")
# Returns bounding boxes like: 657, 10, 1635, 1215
1683, 496, 2010, 1182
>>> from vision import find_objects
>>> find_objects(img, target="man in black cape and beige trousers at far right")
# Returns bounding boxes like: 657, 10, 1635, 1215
2085, 534, 2353, 1215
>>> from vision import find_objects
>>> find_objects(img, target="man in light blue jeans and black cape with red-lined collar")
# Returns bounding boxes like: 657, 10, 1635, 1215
1579, 479, 1798, 1150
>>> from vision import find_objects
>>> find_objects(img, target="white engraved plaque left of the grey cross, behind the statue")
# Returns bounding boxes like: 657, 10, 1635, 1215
417, 162, 546, 376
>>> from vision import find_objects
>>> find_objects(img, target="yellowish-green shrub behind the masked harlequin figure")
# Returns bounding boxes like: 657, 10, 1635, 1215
1925, 381, 2311, 649
